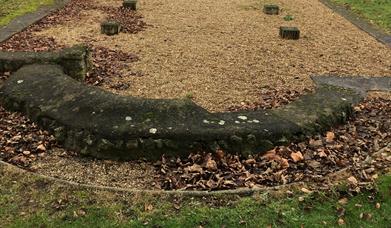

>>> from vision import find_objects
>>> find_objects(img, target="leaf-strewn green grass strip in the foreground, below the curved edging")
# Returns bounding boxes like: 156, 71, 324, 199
0, 163, 391, 227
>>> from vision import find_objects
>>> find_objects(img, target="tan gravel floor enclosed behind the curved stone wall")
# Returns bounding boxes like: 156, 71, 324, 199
29, 0, 391, 111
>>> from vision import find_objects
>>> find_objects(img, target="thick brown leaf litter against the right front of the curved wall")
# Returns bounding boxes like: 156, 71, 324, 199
155, 98, 391, 190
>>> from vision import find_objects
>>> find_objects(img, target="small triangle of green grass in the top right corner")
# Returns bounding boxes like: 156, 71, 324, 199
333, 0, 391, 32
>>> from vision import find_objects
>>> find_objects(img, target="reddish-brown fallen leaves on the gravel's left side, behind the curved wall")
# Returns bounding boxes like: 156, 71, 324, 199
0, 0, 147, 86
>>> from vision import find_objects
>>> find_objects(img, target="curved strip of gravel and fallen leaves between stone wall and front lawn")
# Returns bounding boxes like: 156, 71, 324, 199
0, 69, 391, 190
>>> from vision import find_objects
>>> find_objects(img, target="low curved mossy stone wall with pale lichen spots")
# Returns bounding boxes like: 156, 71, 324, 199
0, 64, 361, 159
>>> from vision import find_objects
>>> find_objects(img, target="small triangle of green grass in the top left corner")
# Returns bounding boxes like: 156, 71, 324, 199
0, 0, 54, 27
